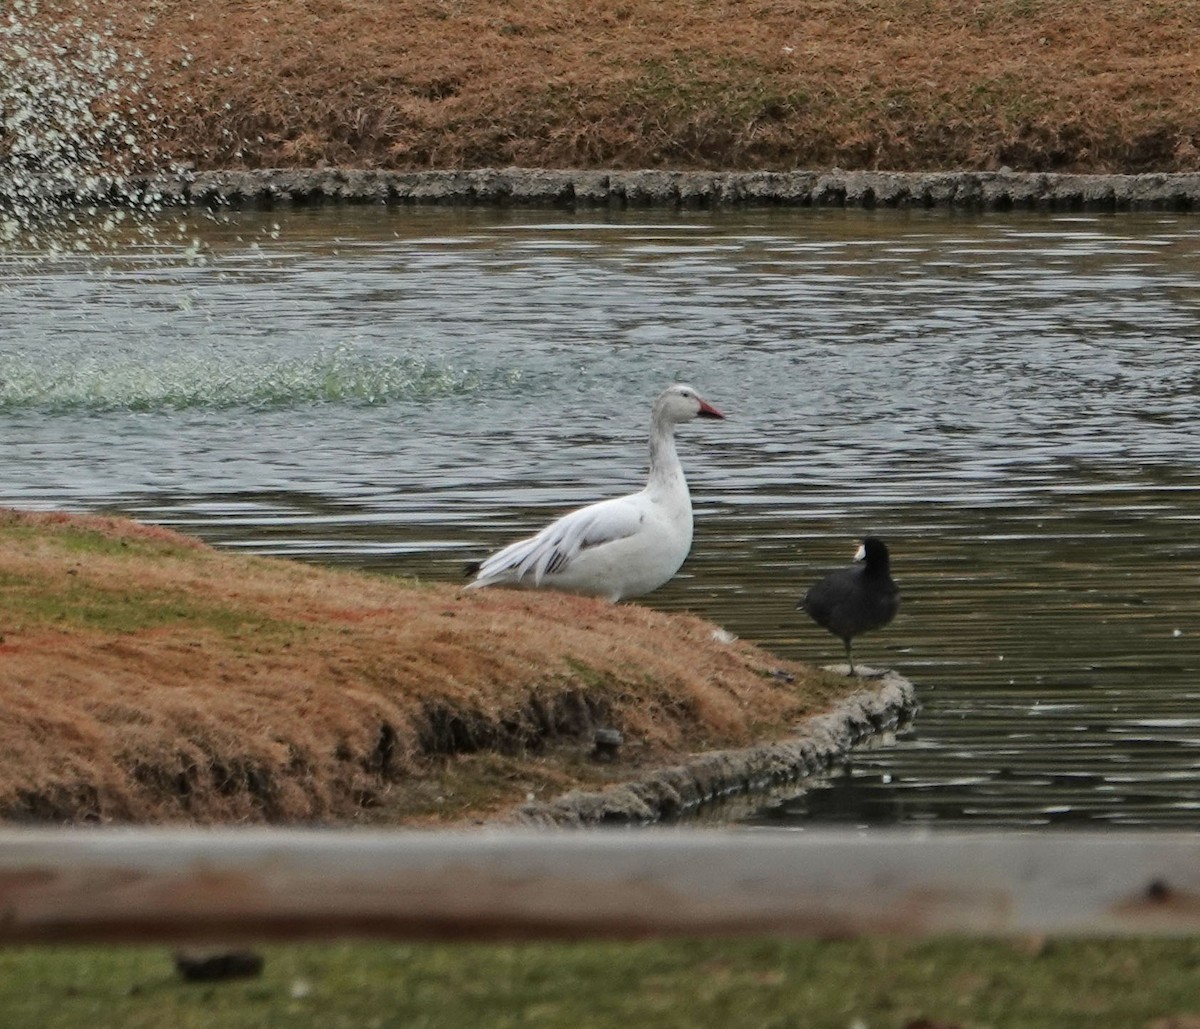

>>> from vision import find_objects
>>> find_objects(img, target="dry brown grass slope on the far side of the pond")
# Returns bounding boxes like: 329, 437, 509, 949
35, 0, 1200, 172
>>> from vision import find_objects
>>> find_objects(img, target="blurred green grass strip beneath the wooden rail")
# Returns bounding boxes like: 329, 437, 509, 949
7, 939, 1200, 1029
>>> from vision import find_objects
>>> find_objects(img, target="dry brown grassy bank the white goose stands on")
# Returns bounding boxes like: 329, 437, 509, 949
0, 512, 847, 823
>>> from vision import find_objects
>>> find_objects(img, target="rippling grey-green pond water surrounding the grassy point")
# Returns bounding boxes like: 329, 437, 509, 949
0, 200, 1200, 826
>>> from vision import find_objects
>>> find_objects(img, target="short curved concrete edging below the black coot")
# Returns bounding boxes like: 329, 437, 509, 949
502, 672, 919, 828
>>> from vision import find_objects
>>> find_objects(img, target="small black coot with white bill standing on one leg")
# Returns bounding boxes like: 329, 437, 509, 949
797, 536, 900, 675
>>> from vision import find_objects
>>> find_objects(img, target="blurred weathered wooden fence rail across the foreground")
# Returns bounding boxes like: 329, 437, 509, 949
0, 829, 1200, 943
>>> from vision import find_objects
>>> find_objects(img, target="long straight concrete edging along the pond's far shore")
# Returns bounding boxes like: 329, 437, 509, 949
14, 168, 1200, 211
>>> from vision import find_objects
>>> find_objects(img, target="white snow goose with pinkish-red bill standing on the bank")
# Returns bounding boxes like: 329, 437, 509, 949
467, 384, 725, 602
